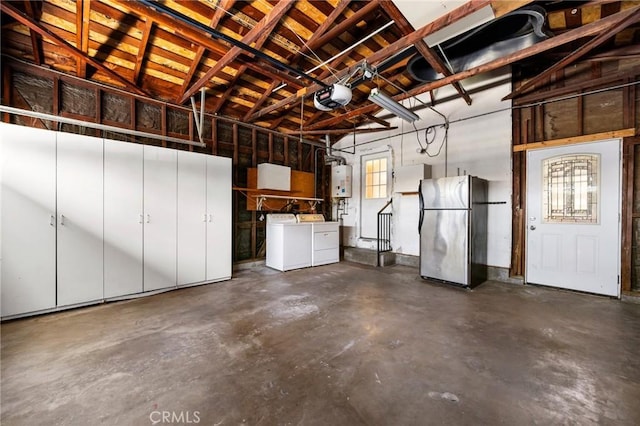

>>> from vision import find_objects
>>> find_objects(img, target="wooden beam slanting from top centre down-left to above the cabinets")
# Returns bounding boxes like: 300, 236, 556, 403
178, 0, 295, 104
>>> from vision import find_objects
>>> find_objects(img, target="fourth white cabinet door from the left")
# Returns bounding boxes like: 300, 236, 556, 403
143, 146, 177, 291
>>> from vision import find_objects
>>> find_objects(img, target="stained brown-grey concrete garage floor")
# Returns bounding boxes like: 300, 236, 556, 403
0, 262, 640, 426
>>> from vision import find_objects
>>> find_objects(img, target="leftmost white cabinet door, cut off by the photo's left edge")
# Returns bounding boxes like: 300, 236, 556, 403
0, 123, 56, 317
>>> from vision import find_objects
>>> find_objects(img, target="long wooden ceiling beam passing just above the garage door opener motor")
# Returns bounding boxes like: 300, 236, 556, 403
250, 0, 532, 120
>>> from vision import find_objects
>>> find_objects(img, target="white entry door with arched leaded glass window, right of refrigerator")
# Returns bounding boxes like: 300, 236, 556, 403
526, 139, 620, 297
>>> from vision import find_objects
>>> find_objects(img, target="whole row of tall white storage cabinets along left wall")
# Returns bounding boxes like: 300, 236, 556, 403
0, 123, 232, 318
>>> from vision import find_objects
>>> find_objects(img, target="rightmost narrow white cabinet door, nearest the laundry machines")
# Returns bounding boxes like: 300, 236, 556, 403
207, 156, 232, 281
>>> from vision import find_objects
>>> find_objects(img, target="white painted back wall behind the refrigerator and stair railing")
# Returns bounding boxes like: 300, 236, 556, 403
334, 70, 512, 268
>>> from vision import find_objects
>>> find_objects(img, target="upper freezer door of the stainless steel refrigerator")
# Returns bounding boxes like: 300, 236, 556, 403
420, 176, 470, 210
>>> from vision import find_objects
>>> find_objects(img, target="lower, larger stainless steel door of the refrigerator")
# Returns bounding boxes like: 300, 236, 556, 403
420, 210, 470, 285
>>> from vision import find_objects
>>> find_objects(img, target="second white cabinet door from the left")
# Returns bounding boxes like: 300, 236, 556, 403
57, 132, 104, 306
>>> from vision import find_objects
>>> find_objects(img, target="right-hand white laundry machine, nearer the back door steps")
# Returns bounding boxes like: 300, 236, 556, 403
297, 214, 340, 266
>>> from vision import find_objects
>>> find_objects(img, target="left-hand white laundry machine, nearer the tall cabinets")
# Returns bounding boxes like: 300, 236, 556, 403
266, 213, 312, 271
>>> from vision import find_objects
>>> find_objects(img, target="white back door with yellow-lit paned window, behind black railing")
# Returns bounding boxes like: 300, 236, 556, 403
360, 152, 391, 239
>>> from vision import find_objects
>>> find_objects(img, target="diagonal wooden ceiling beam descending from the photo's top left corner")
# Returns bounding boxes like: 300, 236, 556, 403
0, 1, 149, 96
